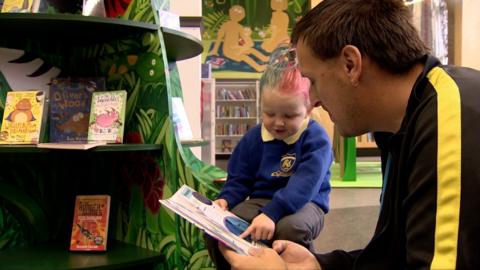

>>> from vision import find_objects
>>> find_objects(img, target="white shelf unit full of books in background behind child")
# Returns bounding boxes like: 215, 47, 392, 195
214, 79, 260, 157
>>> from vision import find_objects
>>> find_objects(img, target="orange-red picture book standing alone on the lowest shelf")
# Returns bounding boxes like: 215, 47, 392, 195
70, 195, 110, 251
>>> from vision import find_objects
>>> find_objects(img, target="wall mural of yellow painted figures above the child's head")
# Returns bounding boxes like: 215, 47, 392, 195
202, 0, 310, 78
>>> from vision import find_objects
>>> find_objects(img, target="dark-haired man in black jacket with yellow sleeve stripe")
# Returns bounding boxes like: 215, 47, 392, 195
221, 0, 480, 270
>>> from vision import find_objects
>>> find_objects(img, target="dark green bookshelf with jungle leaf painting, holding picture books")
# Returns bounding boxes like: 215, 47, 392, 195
0, 8, 225, 269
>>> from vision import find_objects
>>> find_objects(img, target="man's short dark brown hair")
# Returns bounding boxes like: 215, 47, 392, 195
291, 0, 429, 73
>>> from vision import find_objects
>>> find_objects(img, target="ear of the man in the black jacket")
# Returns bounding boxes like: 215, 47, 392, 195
340, 45, 362, 86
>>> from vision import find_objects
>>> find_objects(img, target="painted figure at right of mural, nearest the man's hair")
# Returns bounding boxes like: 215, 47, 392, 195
262, 0, 290, 52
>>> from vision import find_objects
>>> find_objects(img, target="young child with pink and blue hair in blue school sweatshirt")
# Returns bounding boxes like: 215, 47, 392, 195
207, 44, 333, 269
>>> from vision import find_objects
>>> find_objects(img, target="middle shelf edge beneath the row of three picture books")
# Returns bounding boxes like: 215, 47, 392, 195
0, 144, 162, 153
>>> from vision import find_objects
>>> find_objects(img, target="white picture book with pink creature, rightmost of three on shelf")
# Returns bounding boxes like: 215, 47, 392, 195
88, 90, 127, 143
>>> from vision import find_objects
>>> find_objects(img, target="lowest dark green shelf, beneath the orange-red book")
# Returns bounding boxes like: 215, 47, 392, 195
0, 241, 163, 270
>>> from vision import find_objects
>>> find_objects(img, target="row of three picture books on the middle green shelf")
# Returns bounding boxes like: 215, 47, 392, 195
0, 77, 127, 148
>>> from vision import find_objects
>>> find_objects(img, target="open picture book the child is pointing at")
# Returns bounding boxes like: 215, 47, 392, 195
160, 185, 265, 255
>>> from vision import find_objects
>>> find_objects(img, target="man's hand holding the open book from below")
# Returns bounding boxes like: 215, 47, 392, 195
218, 240, 322, 270
